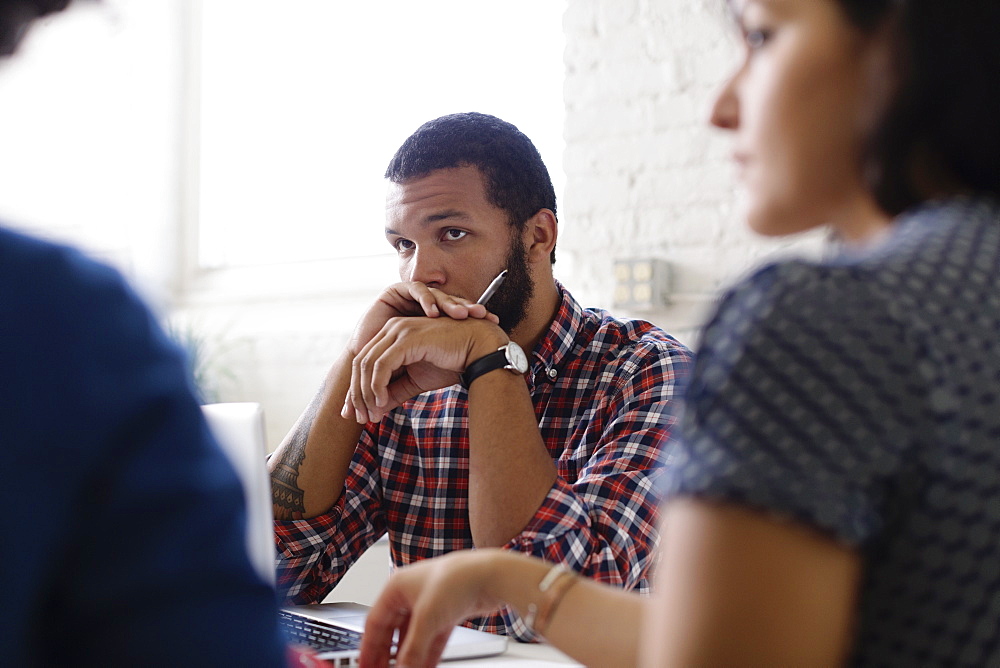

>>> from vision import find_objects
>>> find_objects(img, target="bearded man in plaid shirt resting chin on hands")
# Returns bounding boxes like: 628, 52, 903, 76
270, 113, 691, 640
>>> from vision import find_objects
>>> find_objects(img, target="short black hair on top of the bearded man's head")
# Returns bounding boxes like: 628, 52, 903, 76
385, 112, 556, 262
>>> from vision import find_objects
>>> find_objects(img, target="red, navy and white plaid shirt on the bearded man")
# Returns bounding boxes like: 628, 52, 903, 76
275, 285, 692, 639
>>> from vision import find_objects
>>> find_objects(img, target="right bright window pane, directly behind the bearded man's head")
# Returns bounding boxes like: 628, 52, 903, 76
197, 0, 565, 276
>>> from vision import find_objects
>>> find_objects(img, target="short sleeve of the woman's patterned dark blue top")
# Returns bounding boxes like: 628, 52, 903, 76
666, 263, 930, 546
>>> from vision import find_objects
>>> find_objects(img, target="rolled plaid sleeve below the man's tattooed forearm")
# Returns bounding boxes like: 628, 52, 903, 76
274, 423, 386, 605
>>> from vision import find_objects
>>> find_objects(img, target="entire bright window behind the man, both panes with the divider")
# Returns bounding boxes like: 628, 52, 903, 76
0, 0, 566, 305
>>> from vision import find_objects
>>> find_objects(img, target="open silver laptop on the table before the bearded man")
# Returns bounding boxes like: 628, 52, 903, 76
202, 402, 507, 666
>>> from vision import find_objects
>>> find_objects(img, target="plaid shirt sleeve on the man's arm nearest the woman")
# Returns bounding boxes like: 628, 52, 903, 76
491, 341, 692, 640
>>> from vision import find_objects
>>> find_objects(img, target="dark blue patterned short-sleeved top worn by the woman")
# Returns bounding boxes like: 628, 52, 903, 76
667, 199, 1000, 666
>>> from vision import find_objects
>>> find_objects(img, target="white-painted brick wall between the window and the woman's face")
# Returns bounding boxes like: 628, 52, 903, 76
557, 0, 816, 343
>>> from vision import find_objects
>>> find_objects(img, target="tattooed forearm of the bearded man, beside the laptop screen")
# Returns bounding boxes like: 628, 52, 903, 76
269, 353, 362, 520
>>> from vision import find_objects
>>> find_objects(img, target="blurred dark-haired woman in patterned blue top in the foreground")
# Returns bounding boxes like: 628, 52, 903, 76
364, 0, 1000, 666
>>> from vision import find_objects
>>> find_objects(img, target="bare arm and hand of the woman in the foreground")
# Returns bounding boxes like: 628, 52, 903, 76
362, 500, 861, 667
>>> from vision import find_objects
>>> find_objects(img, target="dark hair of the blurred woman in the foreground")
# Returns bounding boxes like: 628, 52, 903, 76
836, 0, 1000, 215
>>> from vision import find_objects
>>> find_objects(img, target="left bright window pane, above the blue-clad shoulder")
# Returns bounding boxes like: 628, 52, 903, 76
0, 0, 180, 302
